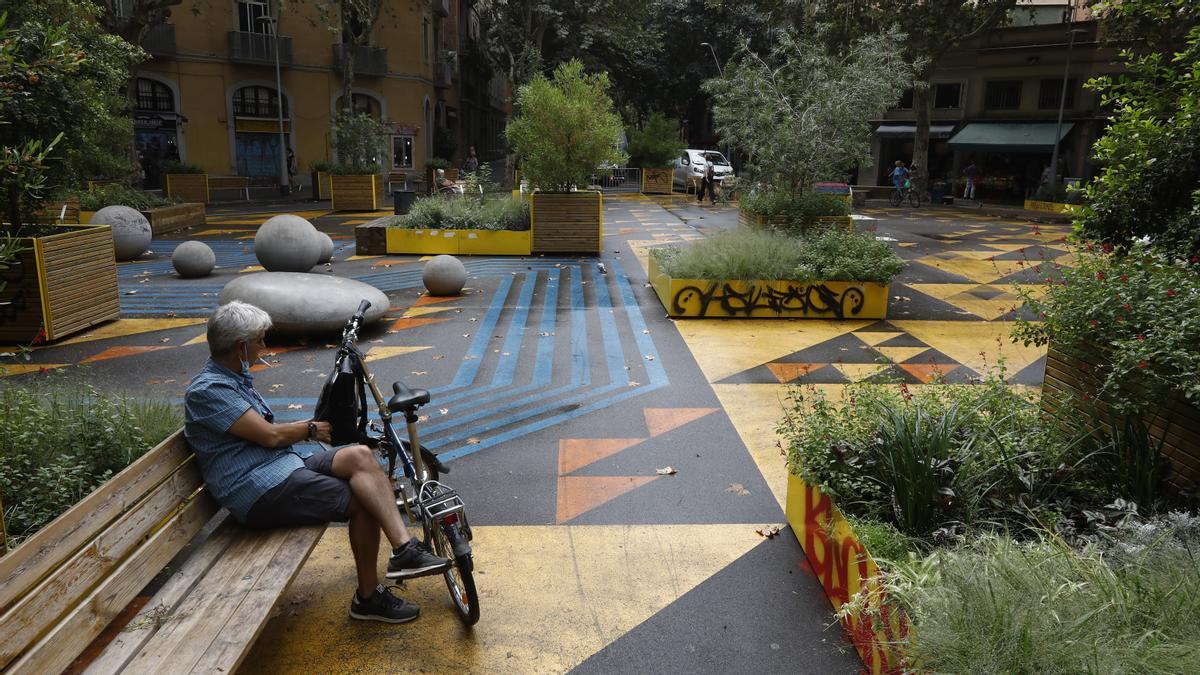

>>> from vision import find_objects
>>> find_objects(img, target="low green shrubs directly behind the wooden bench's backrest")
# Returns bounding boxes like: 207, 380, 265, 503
0, 387, 182, 543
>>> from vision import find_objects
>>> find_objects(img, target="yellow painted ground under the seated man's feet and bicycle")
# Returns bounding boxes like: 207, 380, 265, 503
241, 524, 762, 673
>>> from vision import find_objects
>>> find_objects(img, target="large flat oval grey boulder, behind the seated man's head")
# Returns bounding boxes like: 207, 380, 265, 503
217, 271, 390, 335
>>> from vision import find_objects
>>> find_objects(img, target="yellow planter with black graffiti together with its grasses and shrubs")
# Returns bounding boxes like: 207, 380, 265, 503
649, 228, 904, 318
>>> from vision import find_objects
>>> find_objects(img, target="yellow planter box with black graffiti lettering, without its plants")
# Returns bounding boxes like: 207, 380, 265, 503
649, 256, 890, 318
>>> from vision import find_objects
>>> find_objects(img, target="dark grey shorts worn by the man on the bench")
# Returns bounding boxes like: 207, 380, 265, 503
245, 448, 350, 528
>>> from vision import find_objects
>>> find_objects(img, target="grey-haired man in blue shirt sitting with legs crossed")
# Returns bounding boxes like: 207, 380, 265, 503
184, 301, 451, 623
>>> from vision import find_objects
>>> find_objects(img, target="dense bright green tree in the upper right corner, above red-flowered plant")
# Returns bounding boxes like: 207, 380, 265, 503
1076, 0, 1200, 262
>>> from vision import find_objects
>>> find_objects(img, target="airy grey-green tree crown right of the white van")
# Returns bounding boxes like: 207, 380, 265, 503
704, 29, 912, 195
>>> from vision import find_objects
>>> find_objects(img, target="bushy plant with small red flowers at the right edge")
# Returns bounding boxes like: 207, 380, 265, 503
1013, 244, 1200, 412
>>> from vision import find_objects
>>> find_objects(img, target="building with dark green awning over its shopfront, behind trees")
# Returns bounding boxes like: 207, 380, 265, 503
857, 4, 1123, 202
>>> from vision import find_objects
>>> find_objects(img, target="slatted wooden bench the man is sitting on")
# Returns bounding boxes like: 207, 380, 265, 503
0, 431, 325, 674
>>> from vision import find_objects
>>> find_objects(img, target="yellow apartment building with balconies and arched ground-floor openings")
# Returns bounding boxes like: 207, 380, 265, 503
133, 0, 510, 189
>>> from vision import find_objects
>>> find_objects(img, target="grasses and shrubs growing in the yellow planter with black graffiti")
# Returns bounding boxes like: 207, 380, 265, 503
650, 228, 905, 283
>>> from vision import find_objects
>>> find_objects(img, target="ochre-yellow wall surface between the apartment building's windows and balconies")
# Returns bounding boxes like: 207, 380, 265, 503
139, 0, 458, 184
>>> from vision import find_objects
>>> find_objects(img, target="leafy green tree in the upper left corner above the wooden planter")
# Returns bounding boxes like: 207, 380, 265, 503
0, 0, 142, 227
